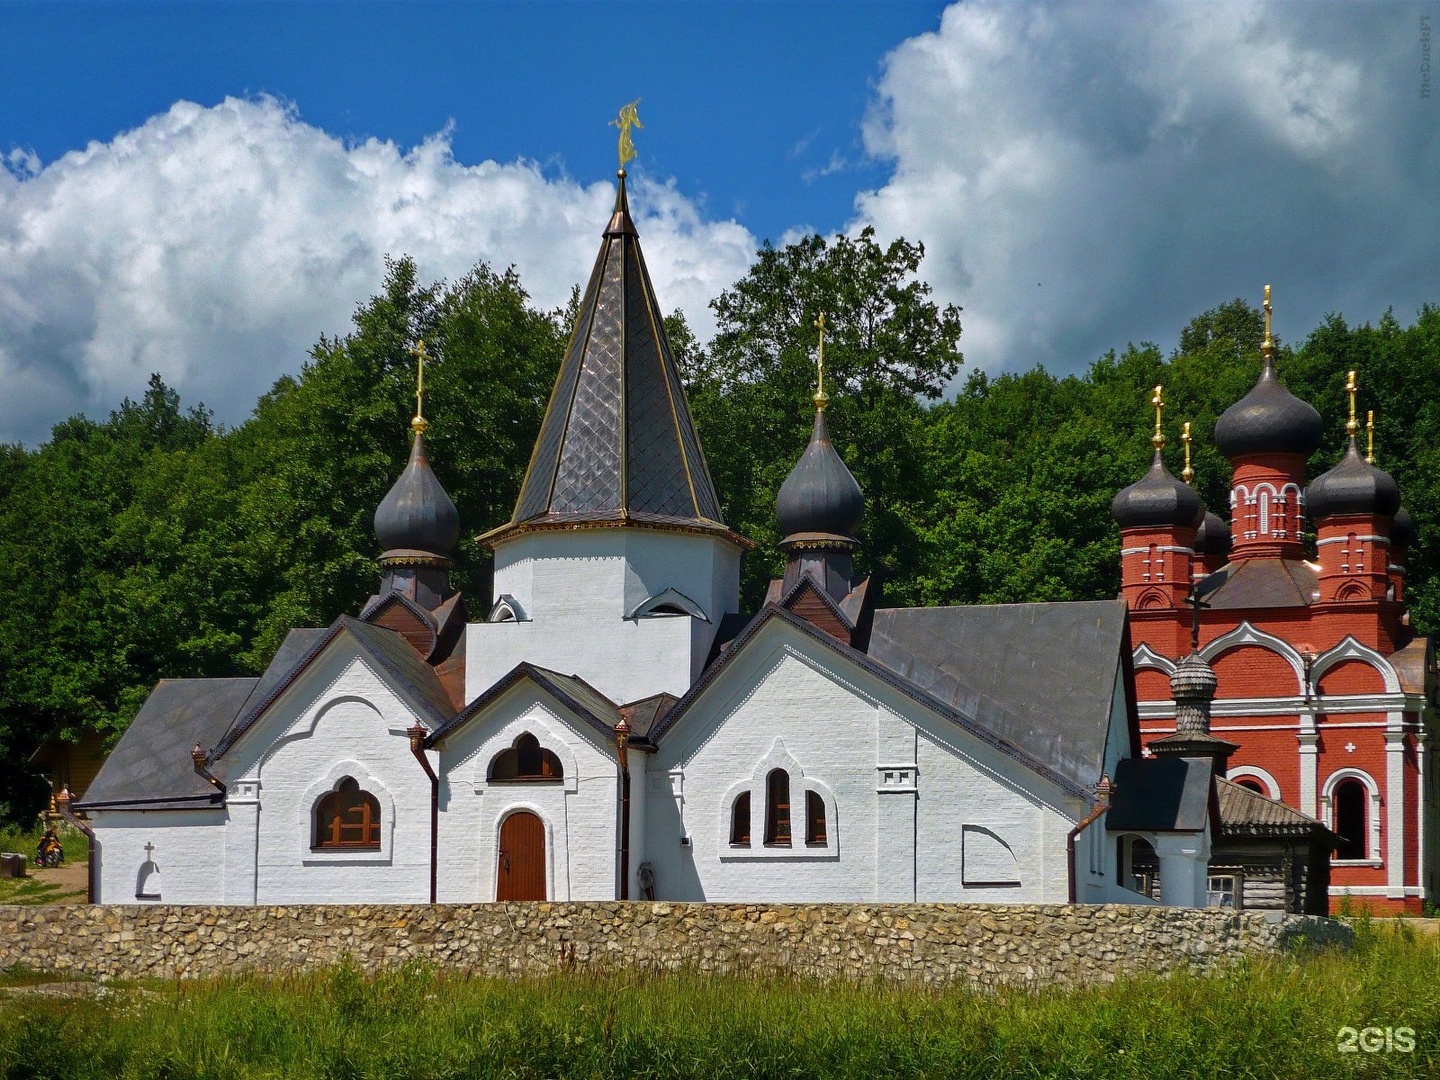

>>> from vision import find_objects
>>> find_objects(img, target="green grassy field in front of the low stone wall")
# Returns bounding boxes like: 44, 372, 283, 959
0, 923, 1440, 1080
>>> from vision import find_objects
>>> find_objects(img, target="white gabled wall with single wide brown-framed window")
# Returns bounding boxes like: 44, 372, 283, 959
222, 639, 431, 904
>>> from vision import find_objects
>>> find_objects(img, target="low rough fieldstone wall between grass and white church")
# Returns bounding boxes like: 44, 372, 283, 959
0, 901, 1352, 986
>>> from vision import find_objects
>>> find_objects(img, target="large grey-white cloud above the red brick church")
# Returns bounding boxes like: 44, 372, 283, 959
855, 0, 1440, 370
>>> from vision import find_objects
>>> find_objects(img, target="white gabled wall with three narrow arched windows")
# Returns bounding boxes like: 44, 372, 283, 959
647, 624, 1074, 903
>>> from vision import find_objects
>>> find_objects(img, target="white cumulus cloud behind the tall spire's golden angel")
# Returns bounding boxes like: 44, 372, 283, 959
0, 98, 756, 442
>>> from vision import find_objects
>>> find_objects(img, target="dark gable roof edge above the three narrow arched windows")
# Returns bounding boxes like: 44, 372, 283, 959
649, 602, 1088, 799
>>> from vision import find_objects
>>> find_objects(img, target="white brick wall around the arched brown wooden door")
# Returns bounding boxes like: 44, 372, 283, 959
438, 683, 619, 903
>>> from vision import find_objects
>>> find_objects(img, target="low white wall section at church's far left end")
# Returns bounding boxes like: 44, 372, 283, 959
89, 808, 225, 904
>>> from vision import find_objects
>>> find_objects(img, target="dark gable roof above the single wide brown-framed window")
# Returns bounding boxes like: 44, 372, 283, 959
207, 615, 451, 762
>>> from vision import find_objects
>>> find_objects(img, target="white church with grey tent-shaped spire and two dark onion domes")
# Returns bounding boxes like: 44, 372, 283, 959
73, 171, 1259, 906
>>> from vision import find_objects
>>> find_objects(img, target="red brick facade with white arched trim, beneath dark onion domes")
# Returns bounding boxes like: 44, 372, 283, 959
1120, 397, 1440, 914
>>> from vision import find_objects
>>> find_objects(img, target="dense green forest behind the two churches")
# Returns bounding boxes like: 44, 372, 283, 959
0, 230, 1440, 819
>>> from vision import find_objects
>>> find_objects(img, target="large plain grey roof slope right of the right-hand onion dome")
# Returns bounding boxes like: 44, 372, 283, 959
870, 600, 1130, 788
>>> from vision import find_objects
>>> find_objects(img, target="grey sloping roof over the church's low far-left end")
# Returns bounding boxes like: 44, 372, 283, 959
75, 678, 261, 809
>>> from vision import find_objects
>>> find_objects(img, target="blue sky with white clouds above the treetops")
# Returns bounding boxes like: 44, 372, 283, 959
0, 0, 1440, 444
